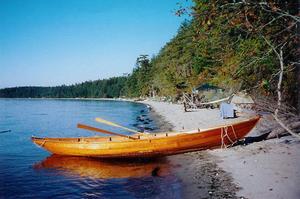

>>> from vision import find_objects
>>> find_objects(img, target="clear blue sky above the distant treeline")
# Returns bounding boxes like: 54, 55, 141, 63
0, 0, 190, 88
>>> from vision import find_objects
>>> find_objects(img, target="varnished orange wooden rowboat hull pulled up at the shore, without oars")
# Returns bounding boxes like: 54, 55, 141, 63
32, 116, 260, 158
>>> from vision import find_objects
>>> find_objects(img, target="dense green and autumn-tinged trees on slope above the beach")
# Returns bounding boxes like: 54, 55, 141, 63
123, 0, 297, 99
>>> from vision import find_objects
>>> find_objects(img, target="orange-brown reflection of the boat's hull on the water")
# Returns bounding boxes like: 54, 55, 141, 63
34, 155, 170, 179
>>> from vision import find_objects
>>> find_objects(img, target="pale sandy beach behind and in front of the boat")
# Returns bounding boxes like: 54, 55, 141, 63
143, 101, 300, 199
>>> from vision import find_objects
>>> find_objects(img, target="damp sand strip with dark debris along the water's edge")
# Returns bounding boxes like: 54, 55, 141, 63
142, 101, 240, 199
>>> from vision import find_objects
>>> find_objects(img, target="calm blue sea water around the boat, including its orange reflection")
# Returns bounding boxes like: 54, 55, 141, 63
0, 99, 182, 198
